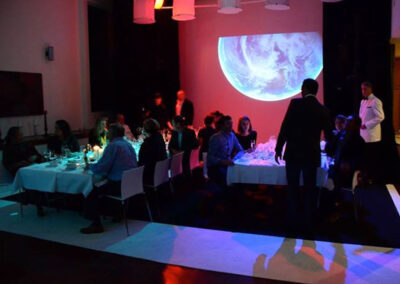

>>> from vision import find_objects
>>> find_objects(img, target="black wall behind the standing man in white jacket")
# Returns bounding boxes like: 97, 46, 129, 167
323, 0, 399, 180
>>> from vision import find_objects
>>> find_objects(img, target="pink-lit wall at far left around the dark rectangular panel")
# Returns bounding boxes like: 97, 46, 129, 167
0, 0, 90, 135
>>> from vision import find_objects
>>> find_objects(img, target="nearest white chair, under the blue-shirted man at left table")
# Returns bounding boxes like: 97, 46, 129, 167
105, 166, 153, 236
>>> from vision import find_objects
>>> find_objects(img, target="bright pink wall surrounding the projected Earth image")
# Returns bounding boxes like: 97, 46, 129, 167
179, 0, 323, 142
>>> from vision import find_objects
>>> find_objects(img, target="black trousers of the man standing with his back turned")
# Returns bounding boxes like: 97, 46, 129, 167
286, 161, 317, 227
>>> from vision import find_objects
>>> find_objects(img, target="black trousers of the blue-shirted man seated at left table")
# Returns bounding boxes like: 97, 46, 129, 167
85, 180, 121, 223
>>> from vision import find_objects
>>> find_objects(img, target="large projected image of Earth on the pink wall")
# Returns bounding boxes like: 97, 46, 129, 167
218, 32, 322, 101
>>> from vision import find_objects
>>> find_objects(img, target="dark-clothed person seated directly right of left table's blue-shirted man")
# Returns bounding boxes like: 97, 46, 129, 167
139, 118, 167, 185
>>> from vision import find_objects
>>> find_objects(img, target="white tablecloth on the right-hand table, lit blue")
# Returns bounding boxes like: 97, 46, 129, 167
227, 157, 328, 186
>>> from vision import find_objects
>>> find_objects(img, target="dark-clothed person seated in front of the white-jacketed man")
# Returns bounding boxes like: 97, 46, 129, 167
331, 116, 365, 188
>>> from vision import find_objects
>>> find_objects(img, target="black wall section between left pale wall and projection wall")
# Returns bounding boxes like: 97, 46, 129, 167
89, 0, 179, 127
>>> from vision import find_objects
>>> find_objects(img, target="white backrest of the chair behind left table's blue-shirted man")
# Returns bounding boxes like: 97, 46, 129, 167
121, 166, 144, 200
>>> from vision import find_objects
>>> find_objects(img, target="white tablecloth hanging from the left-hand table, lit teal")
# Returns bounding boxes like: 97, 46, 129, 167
13, 162, 93, 197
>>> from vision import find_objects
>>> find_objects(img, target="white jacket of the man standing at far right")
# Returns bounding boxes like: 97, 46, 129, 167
359, 94, 385, 143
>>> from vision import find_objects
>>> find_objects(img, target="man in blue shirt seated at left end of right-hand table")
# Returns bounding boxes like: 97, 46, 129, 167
207, 115, 243, 188
